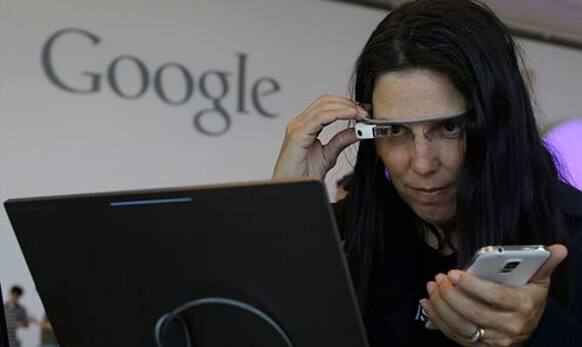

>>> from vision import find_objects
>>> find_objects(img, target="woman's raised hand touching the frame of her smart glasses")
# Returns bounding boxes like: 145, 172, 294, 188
273, 95, 368, 180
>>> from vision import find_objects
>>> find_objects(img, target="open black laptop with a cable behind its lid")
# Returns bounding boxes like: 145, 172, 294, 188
5, 181, 368, 347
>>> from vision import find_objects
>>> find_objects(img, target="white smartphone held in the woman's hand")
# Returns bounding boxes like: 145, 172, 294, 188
467, 245, 551, 287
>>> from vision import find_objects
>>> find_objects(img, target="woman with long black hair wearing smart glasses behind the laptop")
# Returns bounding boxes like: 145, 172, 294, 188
273, 0, 582, 346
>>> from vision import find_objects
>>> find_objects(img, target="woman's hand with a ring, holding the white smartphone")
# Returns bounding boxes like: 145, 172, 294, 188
421, 245, 568, 346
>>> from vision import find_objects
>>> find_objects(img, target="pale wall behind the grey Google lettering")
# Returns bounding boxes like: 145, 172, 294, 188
0, 0, 582, 347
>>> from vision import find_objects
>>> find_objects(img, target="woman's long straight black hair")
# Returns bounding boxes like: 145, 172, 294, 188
347, 0, 567, 309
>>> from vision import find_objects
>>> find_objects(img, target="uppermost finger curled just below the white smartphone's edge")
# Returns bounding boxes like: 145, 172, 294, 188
449, 270, 522, 311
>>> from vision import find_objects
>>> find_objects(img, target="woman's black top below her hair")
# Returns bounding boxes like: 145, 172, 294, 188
334, 185, 582, 347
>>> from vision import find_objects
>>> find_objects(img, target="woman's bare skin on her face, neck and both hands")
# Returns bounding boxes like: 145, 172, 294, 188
273, 69, 567, 346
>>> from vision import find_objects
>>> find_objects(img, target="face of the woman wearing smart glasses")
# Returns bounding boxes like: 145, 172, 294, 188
372, 69, 467, 225
